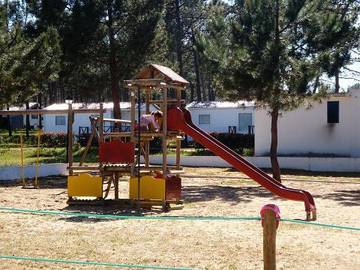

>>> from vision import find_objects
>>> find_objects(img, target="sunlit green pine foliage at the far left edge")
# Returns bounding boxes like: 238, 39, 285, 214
0, 5, 61, 105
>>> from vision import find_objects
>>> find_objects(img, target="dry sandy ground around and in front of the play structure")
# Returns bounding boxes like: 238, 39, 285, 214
0, 168, 360, 270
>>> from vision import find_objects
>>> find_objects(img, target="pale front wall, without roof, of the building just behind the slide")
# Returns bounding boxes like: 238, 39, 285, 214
188, 107, 254, 133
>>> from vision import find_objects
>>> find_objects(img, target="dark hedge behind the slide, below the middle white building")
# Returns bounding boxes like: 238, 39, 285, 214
194, 132, 254, 154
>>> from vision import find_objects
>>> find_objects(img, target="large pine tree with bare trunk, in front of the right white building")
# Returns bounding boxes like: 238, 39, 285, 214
225, 0, 360, 181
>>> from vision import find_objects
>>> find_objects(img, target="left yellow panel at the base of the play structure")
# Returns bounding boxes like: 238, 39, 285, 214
68, 173, 103, 198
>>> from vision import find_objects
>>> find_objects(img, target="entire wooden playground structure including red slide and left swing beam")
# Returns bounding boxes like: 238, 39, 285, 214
1, 65, 316, 220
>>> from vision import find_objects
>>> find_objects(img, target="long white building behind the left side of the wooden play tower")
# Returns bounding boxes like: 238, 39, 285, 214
43, 102, 157, 135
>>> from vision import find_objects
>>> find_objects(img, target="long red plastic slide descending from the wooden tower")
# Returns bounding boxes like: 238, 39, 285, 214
167, 108, 316, 220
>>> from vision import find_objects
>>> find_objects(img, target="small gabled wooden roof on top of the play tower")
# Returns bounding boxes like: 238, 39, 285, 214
134, 64, 189, 86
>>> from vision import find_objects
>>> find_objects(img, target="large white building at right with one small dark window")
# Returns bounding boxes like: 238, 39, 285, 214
255, 89, 360, 157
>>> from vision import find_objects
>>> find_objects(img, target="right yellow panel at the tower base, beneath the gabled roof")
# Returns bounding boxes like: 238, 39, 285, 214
129, 175, 165, 201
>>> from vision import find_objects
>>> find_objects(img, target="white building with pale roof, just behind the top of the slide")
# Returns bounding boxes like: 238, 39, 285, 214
186, 101, 255, 134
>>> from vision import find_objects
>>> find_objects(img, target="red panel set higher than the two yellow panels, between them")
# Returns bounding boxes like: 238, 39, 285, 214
99, 140, 135, 164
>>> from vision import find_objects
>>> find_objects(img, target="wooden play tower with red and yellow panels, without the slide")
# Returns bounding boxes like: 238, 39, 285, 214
68, 64, 188, 207
